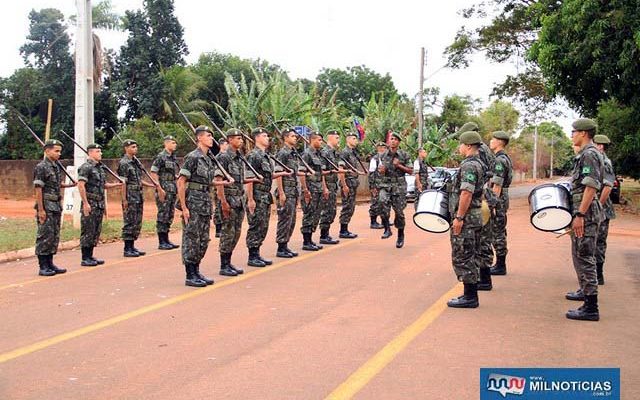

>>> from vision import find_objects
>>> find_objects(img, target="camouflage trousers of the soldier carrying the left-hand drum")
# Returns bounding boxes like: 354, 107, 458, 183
450, 219, 481, 283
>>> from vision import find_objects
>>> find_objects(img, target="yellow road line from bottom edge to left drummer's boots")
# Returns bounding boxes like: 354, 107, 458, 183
326, 283, 462, 400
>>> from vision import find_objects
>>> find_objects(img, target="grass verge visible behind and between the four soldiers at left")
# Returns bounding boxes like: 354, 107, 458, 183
0, 218, 156, 253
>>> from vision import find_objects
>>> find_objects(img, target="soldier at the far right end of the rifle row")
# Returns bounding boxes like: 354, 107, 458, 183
338, 132, 365, 239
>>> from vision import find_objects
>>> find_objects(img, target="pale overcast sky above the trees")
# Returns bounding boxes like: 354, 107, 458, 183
0, 0, 579, 131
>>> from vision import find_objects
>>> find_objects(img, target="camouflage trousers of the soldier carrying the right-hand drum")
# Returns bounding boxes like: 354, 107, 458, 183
571, 218, 598, 296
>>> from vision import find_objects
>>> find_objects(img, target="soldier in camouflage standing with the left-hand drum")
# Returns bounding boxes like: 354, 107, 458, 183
447, 131, 485, 308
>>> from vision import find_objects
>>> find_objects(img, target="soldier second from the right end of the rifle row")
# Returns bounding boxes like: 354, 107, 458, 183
320, 130, 345, 244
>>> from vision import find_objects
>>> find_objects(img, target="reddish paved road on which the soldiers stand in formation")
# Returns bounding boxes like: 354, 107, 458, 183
0, 198, 640, 400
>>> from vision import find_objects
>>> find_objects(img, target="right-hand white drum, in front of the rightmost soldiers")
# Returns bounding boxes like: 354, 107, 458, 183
529, 183, 573, 232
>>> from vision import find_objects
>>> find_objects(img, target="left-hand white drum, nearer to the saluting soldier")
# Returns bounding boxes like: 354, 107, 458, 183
413, 189, 451, 233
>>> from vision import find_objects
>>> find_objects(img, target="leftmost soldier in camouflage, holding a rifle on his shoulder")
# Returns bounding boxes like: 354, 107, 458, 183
33, 139, 75, 276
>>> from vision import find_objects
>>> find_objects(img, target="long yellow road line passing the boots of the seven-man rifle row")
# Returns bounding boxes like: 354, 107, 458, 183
0, 239, 364, 364
